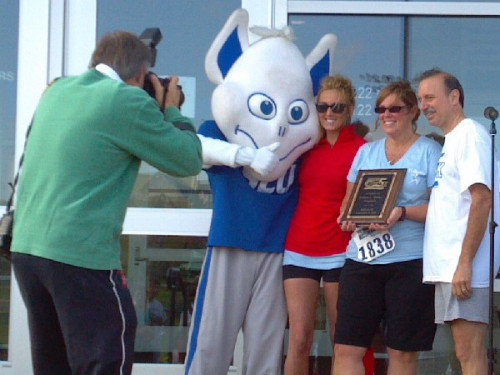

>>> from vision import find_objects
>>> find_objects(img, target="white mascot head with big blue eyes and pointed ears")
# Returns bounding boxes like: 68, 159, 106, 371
205, 9, 337, 181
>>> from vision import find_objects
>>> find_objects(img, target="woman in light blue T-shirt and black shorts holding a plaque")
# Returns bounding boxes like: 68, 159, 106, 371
334, 81, 441, 375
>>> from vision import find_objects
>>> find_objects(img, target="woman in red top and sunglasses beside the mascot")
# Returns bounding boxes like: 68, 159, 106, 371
283, 76, 374, 375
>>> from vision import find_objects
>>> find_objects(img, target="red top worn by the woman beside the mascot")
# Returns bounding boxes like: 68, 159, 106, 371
285, 126, 366, 256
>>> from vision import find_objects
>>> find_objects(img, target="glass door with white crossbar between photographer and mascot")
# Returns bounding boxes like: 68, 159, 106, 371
96, 0, 241, 374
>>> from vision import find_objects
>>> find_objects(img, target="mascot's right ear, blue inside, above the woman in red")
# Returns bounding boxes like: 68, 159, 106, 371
306, 34, 337, 96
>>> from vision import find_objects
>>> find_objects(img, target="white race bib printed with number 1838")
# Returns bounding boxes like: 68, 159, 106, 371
353, 228, 396, 262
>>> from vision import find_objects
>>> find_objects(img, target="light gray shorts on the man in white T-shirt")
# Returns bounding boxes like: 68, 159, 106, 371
435, 283, 490, 324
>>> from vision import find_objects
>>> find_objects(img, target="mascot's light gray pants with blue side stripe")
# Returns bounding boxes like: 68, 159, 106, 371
186, 248, 287, 375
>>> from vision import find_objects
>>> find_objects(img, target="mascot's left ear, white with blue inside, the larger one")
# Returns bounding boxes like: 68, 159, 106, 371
205, 9, 249, 85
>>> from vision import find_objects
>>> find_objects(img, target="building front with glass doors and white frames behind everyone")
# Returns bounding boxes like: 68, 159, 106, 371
0, 0, 500, 375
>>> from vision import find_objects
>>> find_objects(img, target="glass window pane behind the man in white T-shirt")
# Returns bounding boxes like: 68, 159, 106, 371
408, 17, 500, 140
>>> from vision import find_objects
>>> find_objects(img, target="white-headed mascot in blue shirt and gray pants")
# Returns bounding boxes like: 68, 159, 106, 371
185, 9, 337, 375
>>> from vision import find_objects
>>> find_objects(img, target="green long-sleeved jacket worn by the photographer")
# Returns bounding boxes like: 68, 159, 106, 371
11, 69, 202, 270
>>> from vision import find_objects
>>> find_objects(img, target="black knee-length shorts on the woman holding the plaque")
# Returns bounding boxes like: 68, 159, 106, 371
335, 259, 436, 351
